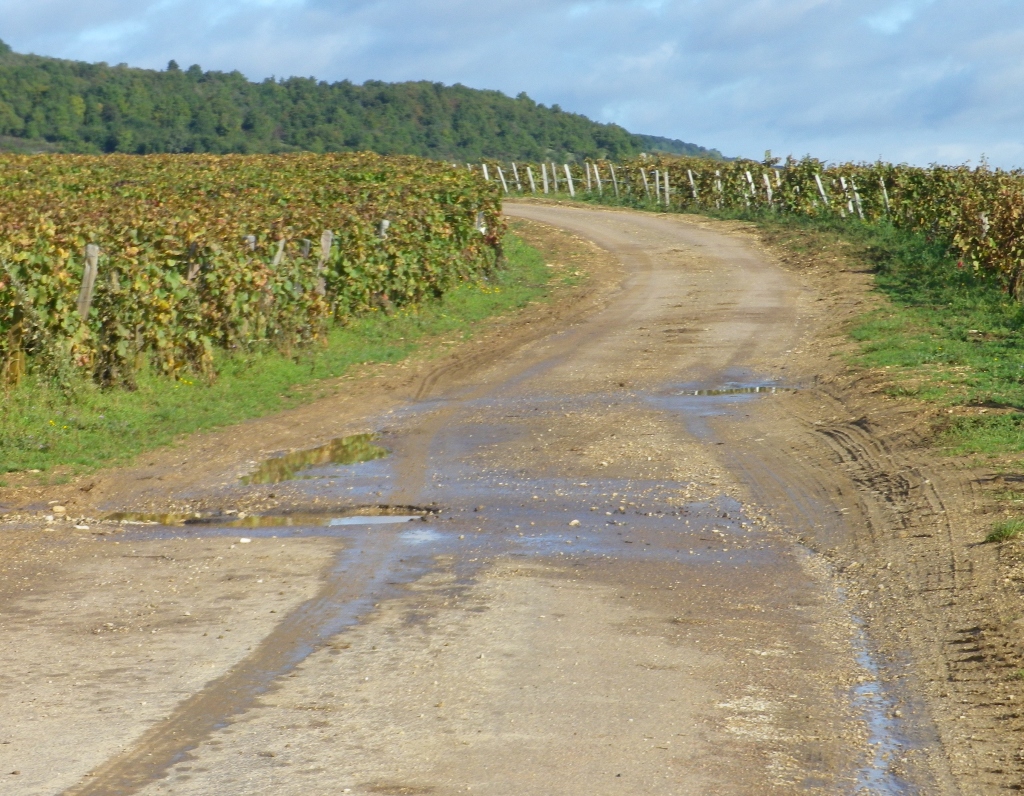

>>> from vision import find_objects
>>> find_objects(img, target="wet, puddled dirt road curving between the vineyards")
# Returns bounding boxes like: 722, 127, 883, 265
0, 204, 961, 796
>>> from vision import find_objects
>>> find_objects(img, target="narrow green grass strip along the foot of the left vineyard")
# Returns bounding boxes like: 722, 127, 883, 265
0, 235, 575, 481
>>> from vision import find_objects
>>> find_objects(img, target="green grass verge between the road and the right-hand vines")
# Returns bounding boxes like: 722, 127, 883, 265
759, 218, 1024, 456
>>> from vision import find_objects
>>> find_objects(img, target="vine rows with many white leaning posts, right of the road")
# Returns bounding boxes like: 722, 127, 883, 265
477, 156, 1024, 298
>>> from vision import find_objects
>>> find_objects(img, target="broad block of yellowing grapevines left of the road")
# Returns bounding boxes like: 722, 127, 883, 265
0, 154, 504, 387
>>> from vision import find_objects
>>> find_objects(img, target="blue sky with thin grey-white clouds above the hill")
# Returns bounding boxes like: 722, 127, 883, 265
0, 0, 1024, 167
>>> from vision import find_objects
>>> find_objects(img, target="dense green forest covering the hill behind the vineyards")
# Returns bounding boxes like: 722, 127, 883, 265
0, 42, 721, 162
